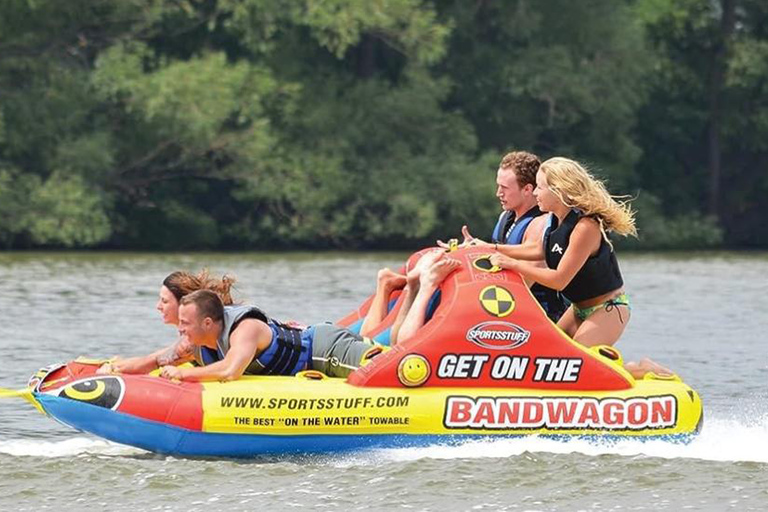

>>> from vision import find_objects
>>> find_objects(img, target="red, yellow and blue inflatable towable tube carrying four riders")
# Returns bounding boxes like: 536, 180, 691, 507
16, 248, 703, 457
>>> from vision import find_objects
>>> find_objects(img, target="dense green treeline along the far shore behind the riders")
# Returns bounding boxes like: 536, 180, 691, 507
0, 0, 768, 249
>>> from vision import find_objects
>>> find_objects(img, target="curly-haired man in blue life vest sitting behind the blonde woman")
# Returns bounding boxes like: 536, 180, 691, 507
444, 151, 568, 322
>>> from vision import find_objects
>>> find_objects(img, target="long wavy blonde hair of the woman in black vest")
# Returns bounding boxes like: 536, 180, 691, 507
540, 157, 637, 240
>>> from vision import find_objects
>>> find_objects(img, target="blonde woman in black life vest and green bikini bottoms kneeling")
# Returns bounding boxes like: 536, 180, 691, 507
491, 157, 671, 376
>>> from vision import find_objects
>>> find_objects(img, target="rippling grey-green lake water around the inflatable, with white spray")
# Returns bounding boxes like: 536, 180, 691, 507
0, 253, 768, 512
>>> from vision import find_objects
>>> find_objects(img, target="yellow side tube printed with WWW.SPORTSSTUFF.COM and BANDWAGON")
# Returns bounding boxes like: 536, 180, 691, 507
202, 372, 702, 437
